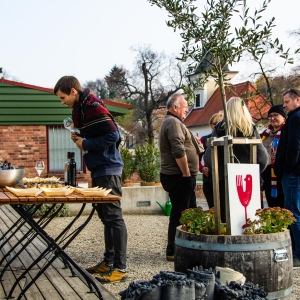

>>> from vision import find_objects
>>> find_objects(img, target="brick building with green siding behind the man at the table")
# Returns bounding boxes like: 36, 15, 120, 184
0, 79, 131, 184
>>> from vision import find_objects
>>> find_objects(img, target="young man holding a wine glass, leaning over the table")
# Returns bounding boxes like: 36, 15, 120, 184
54, 76, 128, 283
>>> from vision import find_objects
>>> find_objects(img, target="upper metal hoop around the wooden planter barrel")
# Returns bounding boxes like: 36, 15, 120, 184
175, 236, 291, 252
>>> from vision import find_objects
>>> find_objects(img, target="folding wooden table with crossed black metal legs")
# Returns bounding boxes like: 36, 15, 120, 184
0, 188, 121, 299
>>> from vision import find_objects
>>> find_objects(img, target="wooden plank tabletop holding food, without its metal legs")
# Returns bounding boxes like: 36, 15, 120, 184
0, 188, 121, 205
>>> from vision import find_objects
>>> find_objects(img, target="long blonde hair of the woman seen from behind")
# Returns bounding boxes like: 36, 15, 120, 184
226, 97, 254, 137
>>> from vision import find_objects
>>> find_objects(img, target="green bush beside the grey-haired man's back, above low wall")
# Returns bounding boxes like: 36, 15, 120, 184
135, 144, 160, 182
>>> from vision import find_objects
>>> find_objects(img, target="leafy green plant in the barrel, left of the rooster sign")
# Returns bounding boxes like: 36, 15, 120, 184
179, 206, 226, 234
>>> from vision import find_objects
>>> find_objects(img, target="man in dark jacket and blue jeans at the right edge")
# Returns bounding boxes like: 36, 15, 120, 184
274, 89, 300, 268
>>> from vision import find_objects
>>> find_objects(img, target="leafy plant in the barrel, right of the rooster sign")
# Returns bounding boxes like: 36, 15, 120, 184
243, 207, 296, 234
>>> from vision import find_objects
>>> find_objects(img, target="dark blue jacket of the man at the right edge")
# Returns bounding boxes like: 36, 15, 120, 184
274, 107, 300, 176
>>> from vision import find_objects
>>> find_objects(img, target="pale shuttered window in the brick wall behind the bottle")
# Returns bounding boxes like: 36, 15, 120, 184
47, 126, 83, 173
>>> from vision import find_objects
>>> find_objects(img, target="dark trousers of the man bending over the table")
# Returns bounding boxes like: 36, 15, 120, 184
92, 175, 127, 269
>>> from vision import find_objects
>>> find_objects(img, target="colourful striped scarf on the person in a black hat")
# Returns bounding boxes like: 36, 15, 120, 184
261, 124, 284, 198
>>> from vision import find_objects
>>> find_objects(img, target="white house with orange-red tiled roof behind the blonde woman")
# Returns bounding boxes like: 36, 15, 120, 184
184, 81, 271, 137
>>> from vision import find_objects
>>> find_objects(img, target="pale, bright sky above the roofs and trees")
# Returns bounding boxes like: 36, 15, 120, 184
0, 0, 300, 88
